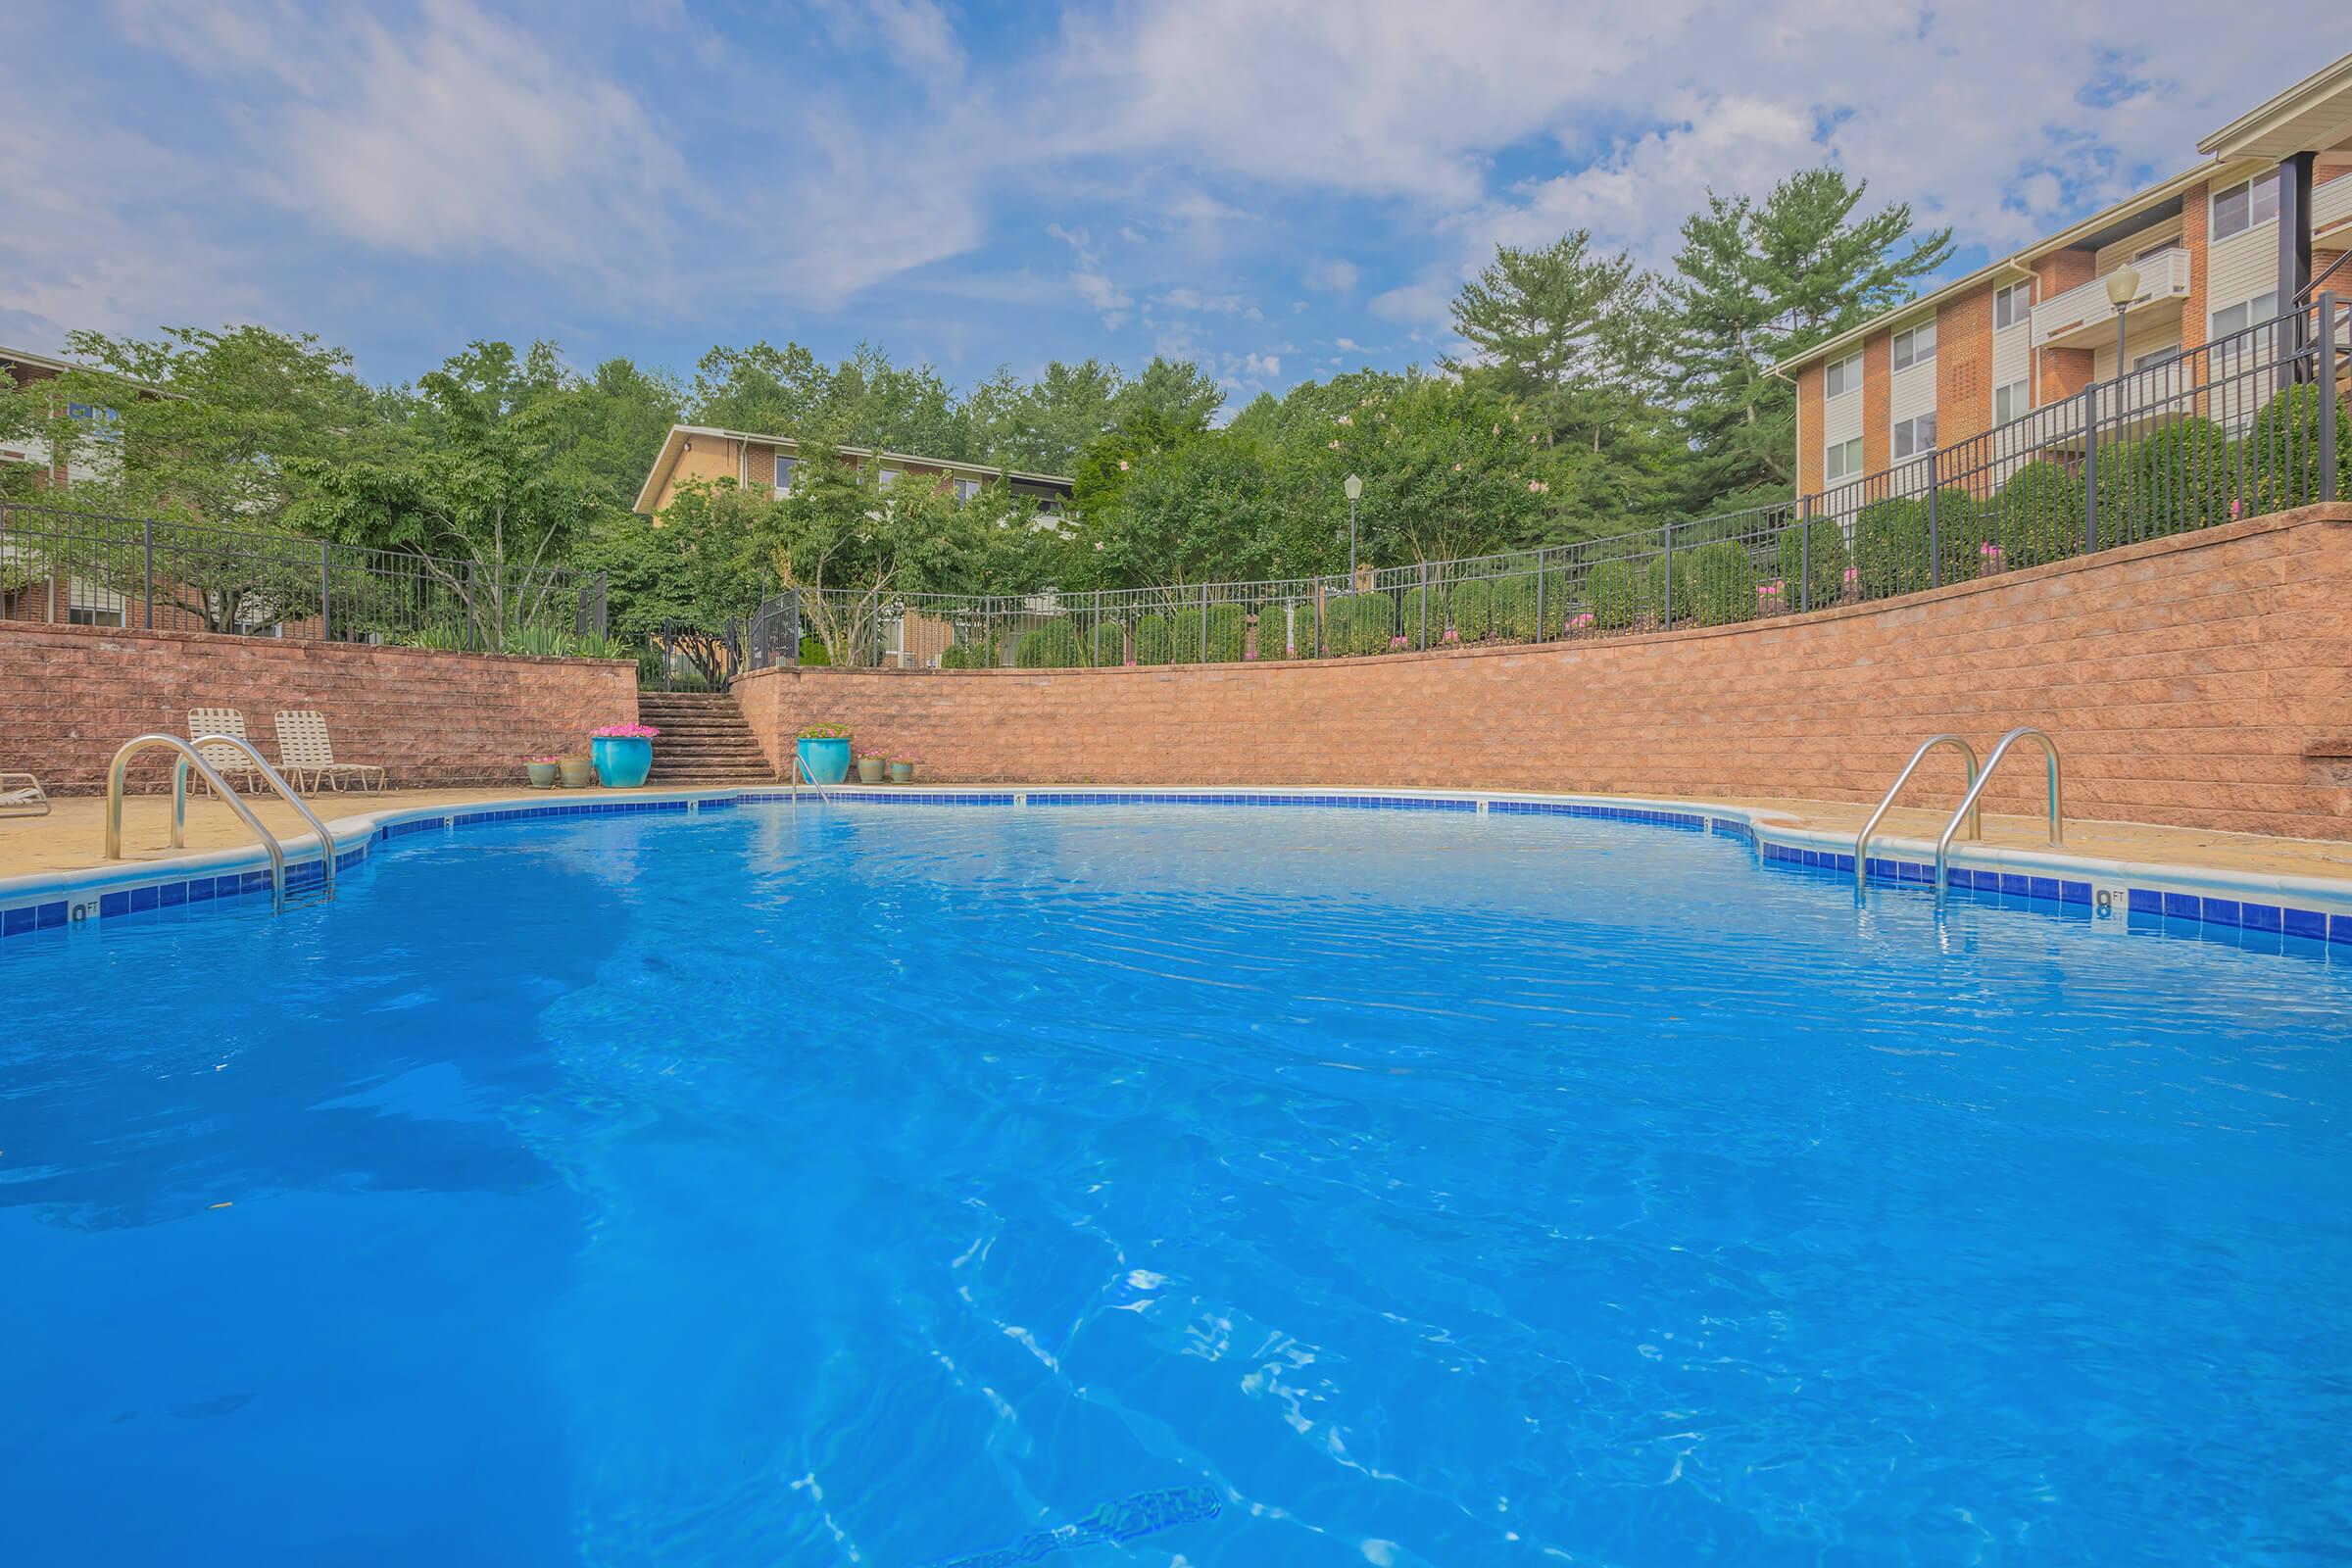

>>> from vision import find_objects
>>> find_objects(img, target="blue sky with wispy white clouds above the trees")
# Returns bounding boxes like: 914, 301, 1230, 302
0, 0, 2352, 407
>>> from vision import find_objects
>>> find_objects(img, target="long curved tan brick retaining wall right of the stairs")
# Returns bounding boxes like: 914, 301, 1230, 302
736, 506, 2352, 839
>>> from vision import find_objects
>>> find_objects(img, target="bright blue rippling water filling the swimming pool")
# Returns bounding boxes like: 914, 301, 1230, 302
0, 807, 2352, 1568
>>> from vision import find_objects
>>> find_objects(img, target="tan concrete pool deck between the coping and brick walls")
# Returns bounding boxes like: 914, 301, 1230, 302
0, 785, 2352, 898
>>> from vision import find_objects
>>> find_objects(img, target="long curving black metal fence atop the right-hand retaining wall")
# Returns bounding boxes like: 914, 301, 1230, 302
743, 294, 2352, 670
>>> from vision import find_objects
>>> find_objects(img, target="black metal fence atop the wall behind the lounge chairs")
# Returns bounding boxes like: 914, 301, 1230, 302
0, 506, 618, 654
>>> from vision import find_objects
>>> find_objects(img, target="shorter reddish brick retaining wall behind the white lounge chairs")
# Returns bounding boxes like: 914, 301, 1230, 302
0, 623, 637, 795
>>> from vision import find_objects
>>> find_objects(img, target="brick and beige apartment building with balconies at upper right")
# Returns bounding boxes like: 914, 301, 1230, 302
1776, 54, 2352, 494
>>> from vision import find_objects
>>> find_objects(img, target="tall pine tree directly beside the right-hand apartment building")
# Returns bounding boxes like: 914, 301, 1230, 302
1653, 170, 1952, 511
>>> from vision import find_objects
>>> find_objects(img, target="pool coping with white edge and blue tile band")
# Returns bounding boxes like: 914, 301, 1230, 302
0, 785, 2352, 950
